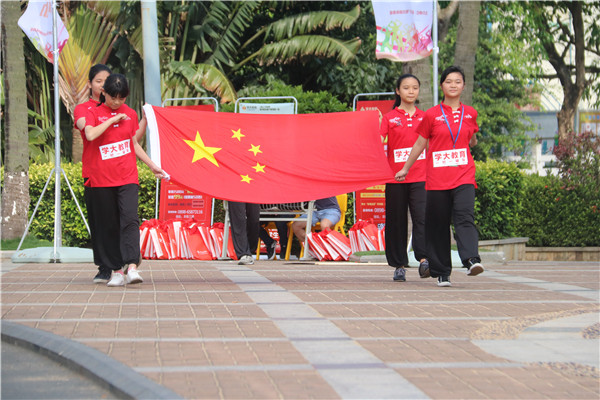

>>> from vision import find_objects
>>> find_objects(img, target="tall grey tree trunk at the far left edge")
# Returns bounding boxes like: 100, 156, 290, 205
1, 1, 29, 239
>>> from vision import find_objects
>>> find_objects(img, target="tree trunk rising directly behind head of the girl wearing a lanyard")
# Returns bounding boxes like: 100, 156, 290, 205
454, 1, 481, 104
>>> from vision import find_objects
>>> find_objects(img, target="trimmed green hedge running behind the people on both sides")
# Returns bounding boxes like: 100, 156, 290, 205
21, 161, 600, 247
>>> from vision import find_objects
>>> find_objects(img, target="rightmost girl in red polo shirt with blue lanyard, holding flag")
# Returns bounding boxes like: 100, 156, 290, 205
396, 66, 484, 287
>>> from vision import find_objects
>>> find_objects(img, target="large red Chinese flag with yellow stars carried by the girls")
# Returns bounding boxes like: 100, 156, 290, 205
144, 105, 393, 203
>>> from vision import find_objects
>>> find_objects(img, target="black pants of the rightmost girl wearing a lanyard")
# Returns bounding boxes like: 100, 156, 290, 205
425, 185, 479, 278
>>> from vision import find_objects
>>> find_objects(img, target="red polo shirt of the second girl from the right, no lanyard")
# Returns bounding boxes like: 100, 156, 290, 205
379, 108, 427, 183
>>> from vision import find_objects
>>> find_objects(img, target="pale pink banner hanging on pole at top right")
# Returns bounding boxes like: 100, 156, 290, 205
372, 1, 434, 61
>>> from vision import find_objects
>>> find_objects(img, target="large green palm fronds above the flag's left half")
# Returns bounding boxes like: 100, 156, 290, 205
157, 1, 360, 102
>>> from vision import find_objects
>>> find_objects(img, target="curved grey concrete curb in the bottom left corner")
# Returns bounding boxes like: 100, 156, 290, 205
0, 320, 182, 399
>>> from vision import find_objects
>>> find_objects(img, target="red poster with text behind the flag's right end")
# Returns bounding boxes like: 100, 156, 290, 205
354, 100, 394, 228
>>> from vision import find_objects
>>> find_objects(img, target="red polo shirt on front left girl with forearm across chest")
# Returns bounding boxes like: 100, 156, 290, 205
85, 104, 139, 187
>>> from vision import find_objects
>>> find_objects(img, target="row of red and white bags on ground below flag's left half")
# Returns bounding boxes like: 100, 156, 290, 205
140, 219, 237, 260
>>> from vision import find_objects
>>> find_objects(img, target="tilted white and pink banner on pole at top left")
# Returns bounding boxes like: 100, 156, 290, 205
18, 0, 69, 62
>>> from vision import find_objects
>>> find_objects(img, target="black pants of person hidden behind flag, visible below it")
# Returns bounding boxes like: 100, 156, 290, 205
228, 201, 260, 258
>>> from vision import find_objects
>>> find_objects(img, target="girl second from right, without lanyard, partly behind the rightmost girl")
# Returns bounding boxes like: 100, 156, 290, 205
379, 74, 427, 282
